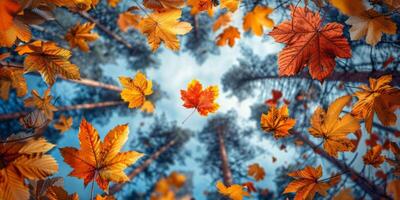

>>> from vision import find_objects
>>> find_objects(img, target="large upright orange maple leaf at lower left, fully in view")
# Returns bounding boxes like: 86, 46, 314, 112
60, 119, 143, 192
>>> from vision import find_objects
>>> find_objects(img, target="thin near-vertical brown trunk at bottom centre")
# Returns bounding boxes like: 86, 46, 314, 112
217, 127, 233, 185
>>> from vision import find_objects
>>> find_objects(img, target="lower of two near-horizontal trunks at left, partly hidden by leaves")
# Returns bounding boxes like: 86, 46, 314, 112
0, 101, 125, 121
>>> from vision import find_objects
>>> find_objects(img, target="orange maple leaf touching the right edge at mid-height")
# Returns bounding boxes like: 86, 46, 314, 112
351, 75, 400, 133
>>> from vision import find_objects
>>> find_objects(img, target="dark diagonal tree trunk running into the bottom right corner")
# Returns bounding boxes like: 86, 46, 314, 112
293, 132, 391, 199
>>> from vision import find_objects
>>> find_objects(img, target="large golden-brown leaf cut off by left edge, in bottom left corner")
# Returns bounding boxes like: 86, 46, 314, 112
0, 133, 58, 200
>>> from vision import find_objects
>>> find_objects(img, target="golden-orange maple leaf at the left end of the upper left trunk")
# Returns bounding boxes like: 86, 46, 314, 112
15, 41, 80, 86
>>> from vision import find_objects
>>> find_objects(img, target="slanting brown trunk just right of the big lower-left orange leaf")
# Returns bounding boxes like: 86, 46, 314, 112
109, 140, 176, 195
